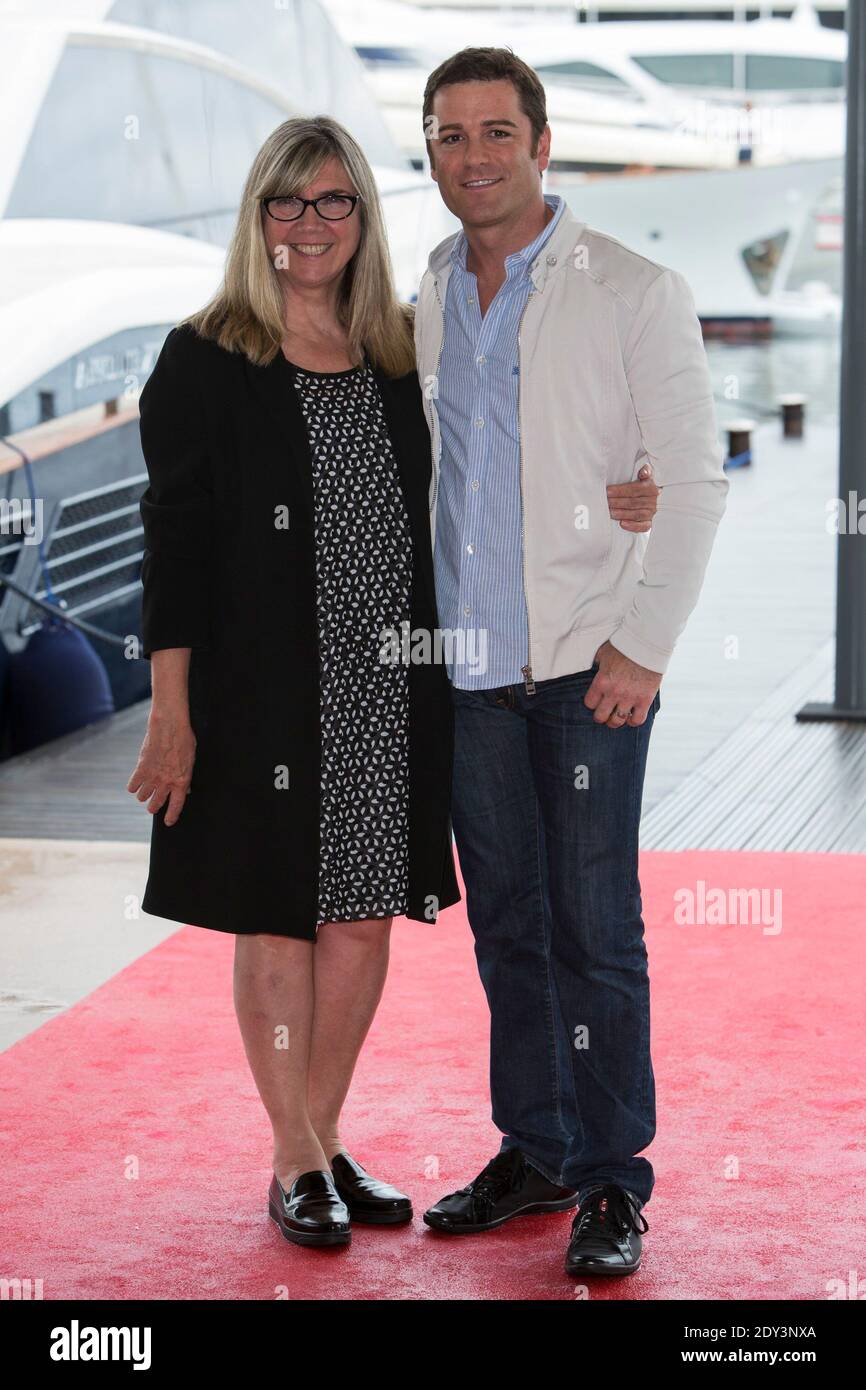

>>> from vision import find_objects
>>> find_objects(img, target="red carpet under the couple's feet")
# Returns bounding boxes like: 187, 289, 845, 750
0, 852, 866, 1300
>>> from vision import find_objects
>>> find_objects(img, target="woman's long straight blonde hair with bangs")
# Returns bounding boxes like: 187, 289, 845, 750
183, 115, 416, 377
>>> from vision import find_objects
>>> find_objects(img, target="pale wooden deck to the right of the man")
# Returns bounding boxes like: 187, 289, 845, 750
641, 421, 866, 852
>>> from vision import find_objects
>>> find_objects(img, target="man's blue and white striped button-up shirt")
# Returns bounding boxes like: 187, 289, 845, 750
434, 195, 566, 689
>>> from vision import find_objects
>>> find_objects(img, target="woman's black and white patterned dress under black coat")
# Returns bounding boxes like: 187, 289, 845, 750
292, 363, 411, 926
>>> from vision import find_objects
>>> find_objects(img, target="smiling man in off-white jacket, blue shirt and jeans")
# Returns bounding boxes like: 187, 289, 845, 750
416, 49, 728, 1276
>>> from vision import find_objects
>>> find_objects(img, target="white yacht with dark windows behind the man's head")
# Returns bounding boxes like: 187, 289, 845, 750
327, 0, 847, 172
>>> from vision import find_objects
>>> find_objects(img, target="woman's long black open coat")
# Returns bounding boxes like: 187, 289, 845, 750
139, 325, 460, 940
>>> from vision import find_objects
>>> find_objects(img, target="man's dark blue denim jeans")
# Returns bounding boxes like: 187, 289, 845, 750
452, 664, 660, 1205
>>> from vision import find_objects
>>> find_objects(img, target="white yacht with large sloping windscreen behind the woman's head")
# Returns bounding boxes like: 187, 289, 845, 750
0, 0, 452, 290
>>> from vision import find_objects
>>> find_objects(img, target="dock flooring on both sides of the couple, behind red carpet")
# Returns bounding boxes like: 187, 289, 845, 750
0, 421, 866, 1047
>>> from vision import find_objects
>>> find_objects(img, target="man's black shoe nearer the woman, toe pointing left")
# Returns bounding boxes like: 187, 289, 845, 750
424, 1148, 577, 1236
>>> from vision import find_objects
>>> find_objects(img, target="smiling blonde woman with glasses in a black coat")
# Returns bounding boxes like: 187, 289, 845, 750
128, 117, 656, 1244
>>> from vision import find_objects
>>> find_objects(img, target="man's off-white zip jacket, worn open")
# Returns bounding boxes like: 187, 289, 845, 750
414, 209, 730, 685
